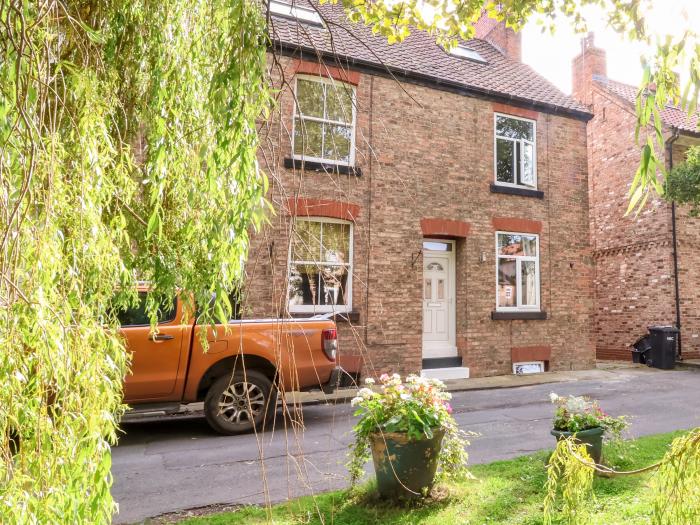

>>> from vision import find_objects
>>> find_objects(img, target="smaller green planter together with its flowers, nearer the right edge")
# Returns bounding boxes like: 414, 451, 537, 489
549, 393, 628, 464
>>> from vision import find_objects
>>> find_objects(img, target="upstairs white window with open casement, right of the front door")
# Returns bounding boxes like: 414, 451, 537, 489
495, 114, 537, 189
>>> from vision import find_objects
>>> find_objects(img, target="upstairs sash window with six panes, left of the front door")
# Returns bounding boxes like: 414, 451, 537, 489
292, 76, 355, 166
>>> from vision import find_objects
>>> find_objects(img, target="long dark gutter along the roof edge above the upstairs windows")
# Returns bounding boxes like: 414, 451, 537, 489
271, 40, 593, 122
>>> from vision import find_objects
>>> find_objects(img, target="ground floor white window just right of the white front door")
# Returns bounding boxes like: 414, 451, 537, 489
496, 232, 540, 311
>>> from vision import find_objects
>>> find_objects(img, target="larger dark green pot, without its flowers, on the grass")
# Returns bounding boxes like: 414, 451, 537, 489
371, 428, 445, 499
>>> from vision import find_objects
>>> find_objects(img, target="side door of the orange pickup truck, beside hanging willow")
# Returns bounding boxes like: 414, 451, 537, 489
119, 292, 191, 403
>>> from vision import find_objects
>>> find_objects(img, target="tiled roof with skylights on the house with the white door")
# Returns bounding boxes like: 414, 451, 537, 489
271, 0, 590, 118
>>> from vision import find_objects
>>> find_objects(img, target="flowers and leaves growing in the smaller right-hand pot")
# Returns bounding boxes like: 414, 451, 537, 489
549, 393, 629, 439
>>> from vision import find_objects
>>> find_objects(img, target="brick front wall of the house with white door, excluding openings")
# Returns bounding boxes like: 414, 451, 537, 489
247, 55, 594, 376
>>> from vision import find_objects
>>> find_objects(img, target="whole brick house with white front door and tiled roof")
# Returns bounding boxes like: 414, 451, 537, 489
243, 0, 594, 378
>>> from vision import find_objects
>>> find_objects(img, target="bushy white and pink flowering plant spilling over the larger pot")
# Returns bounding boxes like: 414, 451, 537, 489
348, 374, 469, 485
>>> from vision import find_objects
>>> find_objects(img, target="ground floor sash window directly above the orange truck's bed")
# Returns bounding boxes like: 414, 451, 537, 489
288, 218, 352, 313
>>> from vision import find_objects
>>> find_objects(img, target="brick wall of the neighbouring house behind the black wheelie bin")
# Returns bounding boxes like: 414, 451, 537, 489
588, 82, 700, 359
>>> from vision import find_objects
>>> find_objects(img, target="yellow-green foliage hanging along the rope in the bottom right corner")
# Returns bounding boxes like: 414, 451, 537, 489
544, 428, 700, 525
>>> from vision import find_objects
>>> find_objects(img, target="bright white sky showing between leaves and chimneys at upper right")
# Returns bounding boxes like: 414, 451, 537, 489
522, 0, 700, 94
